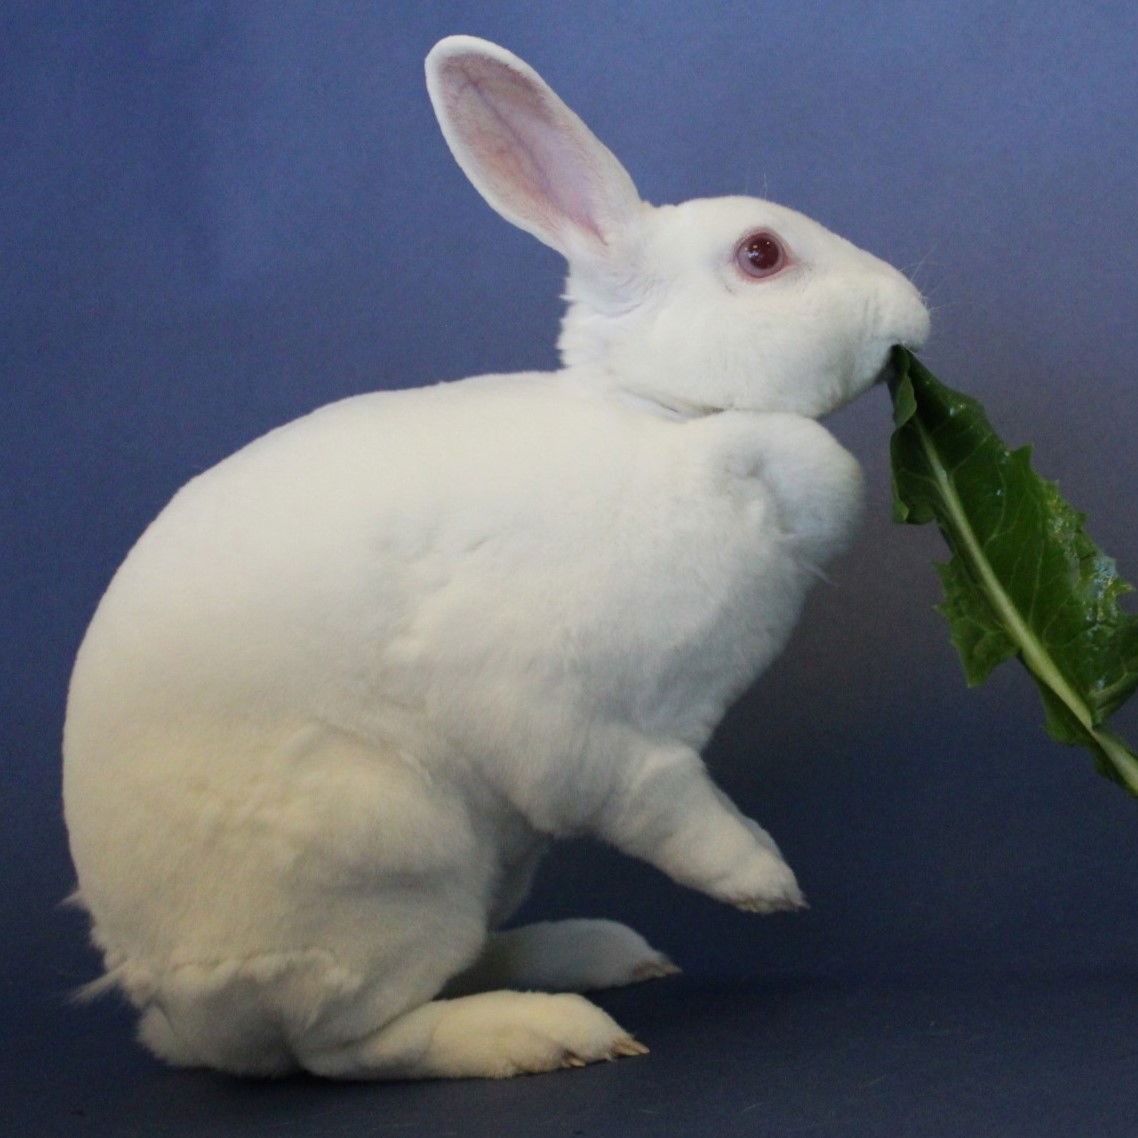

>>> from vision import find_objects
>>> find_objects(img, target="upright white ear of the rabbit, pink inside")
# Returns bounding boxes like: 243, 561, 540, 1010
427, 35, 641, 259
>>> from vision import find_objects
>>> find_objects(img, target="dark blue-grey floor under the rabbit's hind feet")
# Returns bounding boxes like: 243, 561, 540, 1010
11, 973, 1138, 1138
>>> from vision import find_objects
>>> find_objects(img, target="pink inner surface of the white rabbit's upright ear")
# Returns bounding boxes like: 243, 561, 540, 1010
446, 57, 604, 244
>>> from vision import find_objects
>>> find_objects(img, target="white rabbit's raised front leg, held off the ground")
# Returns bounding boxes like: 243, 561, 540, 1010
594, 747, 806, 913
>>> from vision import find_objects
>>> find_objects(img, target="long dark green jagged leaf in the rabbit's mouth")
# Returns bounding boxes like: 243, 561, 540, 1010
890, 348, 1138, 795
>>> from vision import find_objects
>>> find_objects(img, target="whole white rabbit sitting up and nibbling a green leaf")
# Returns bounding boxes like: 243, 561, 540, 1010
64, 36, 927, 1078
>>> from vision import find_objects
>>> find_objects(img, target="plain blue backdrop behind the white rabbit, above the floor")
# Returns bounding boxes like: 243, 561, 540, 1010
0, 0, 1138, 1128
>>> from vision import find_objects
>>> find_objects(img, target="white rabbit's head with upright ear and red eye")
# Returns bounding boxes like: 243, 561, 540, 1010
427, 36, 929, 417
